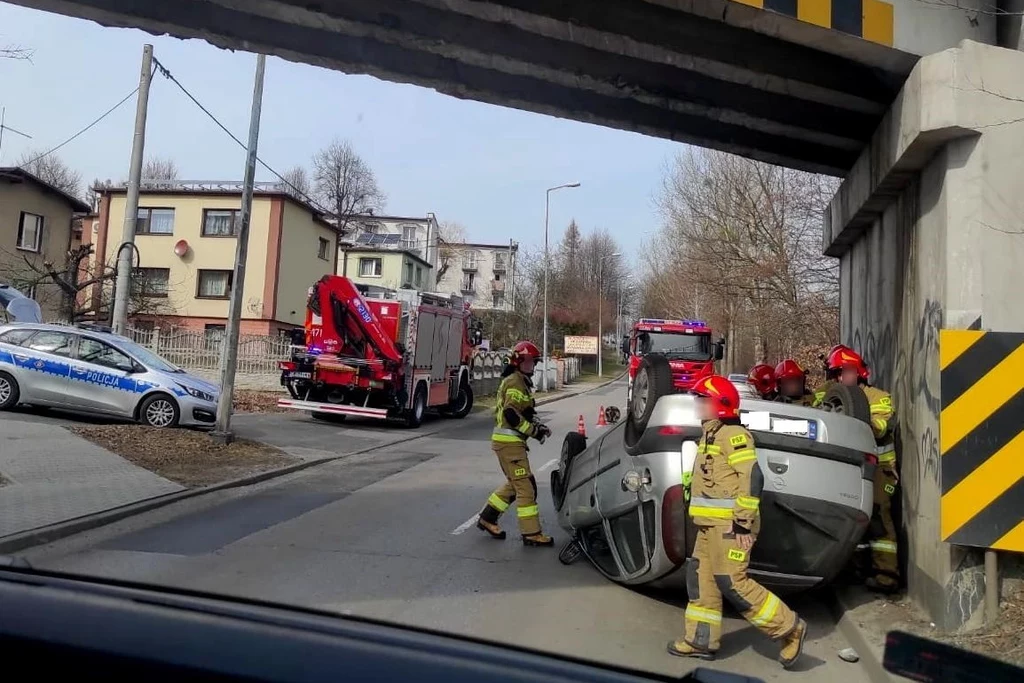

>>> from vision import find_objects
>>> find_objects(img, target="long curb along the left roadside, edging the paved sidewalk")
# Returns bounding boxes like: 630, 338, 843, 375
0, 432, 436, 555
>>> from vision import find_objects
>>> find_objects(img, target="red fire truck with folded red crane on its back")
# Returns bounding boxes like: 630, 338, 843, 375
278, 275, 480, 427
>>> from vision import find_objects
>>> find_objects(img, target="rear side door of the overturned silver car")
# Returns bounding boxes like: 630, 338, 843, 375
595, 422, 653, 581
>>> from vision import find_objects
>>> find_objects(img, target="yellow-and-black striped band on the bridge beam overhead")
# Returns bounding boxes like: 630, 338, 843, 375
734, 0, 895, 47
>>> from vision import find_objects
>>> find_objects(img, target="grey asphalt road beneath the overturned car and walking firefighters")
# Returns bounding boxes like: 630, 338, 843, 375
25, 382, 868, 682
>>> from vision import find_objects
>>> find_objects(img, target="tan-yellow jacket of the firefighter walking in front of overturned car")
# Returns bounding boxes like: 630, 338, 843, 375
690, 420, 764, 530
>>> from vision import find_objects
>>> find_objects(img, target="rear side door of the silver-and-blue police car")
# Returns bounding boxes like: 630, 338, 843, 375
11, 330, 75, 405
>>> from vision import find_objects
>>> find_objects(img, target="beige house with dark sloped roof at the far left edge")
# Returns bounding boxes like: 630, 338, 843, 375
0, 168, 89, 319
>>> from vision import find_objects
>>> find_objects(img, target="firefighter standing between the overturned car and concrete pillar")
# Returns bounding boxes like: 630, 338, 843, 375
815, 346, 900, 593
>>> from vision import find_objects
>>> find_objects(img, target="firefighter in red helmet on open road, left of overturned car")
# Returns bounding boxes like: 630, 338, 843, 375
476, 341, 555, 547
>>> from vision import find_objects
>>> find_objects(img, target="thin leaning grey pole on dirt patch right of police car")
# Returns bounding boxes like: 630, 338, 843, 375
211, 54, 266, 443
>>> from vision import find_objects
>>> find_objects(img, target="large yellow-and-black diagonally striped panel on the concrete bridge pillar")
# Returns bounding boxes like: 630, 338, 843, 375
939, 330, 1024, 552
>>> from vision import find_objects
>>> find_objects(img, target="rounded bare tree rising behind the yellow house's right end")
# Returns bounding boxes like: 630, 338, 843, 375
313, 139, 386, 235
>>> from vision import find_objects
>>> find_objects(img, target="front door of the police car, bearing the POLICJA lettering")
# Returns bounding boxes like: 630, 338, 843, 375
68, 336, 138, 417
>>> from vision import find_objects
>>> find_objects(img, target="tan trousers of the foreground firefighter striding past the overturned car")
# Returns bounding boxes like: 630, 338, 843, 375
683, 526, 798, 652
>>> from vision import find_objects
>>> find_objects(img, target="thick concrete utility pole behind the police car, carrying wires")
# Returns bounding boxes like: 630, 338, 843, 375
111, 45, 153, 335
